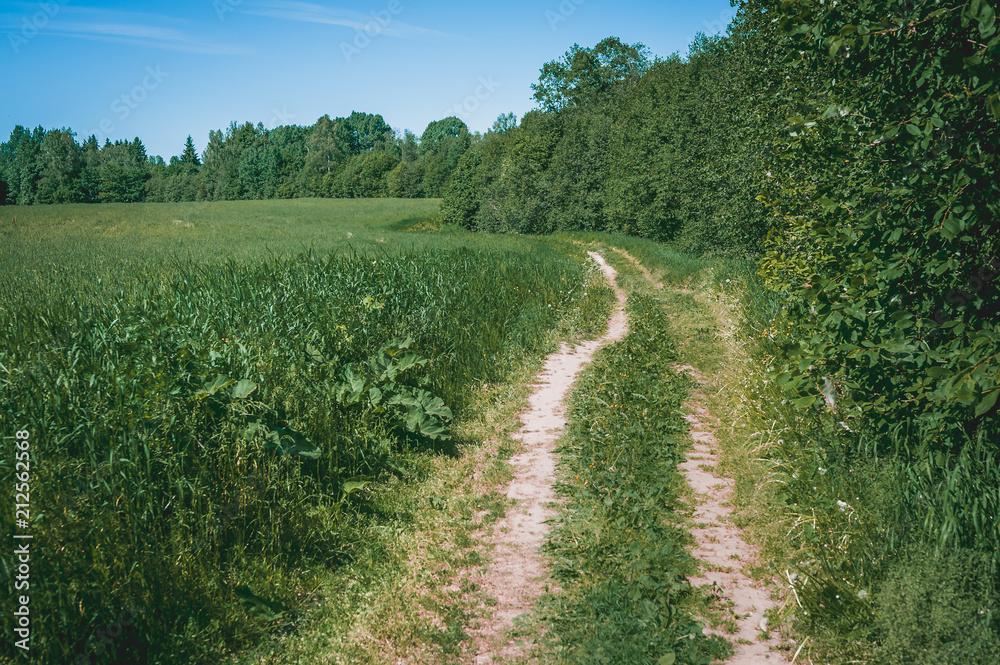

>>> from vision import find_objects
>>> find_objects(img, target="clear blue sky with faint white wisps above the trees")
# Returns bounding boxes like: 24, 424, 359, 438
0, 0, 734, 159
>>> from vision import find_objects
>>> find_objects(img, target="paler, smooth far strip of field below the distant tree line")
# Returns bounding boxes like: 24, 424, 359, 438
0, 199, 450, 266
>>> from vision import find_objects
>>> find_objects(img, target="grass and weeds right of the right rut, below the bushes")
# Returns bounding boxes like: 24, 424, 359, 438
716, 264, 1000, 664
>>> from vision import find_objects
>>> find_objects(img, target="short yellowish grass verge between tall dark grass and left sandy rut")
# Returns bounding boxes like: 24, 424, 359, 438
234, 362, 537, 665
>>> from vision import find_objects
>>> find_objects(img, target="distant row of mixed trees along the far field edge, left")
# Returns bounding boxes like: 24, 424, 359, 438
0, 112, 480, 205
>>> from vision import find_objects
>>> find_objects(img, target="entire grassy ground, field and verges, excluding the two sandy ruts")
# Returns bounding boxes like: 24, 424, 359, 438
0, 199, 1000, 664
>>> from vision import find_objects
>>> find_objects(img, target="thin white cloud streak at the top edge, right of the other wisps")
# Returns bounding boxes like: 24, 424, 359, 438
242, 0, 451, 39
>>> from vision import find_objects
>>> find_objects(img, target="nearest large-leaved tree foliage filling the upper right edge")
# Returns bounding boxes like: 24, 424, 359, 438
763, 0, 1000, 446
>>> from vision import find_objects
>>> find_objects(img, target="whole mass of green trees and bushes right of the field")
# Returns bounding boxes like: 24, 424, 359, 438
442, 6, 1000, 446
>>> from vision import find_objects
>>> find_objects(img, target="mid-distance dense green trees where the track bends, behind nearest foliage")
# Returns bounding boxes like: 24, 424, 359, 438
443, 33, 777, 254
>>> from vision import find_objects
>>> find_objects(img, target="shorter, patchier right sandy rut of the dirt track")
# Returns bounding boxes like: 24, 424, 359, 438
677, 367, 786, 665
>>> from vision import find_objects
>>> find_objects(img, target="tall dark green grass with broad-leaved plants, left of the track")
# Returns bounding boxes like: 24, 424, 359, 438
0, 205, 610, 663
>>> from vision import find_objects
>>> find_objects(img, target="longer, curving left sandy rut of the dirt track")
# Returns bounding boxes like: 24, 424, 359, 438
475, 252, 628, 664
